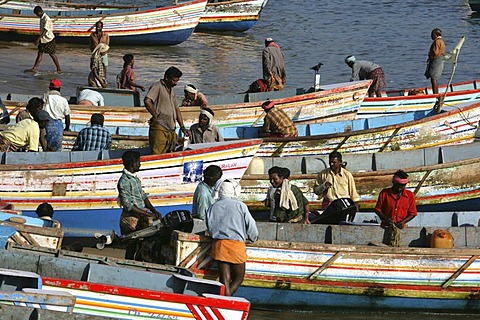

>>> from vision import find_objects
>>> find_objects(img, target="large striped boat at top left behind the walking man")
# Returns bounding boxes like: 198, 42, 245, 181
0, 0, 207, 45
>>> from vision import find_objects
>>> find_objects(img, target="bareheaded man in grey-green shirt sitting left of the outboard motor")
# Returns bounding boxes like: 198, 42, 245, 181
117, 151, 160, 260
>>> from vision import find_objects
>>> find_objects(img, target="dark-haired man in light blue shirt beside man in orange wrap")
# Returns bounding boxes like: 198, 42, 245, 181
192, 165, 222, 220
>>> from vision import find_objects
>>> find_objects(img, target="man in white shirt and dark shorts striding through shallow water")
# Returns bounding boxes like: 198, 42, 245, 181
26, 6, 62, 73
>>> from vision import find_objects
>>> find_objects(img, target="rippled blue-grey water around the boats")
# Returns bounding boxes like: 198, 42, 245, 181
0, 0, 480, 320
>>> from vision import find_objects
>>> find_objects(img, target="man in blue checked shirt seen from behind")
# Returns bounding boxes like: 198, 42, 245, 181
72, 113, 112, 151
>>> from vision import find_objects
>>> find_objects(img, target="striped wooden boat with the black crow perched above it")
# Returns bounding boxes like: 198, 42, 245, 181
3, 80, 371, 136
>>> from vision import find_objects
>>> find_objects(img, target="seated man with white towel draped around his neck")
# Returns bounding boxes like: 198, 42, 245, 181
265, 166, 310, 223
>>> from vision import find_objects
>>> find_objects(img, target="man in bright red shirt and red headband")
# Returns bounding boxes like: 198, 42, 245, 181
375, 170, 417, 229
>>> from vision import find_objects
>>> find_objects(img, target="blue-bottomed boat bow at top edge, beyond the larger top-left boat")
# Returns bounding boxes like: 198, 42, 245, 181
195, 0, 268, 32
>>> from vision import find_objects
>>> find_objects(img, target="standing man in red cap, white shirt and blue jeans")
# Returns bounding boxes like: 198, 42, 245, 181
43, 79, 70, 151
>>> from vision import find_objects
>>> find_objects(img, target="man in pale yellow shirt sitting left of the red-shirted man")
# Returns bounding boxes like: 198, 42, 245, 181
309, 151, 360, 224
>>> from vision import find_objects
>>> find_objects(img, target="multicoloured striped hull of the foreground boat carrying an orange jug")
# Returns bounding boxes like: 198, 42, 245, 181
168, 231, 480, 312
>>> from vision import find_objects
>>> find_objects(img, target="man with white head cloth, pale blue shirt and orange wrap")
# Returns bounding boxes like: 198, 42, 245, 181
206, 179, 258, 296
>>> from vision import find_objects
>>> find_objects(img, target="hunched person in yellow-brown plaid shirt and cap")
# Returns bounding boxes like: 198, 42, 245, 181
259, 100, 298, 137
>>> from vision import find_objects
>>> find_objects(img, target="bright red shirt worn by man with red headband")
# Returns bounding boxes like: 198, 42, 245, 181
375, 188, 417, 225
